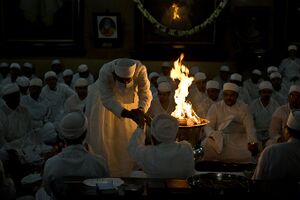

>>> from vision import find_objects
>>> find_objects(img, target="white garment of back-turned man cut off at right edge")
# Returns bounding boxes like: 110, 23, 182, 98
252, 138, 300, 180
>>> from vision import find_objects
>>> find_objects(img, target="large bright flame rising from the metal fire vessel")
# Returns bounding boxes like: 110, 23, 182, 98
170, 54, 201, 125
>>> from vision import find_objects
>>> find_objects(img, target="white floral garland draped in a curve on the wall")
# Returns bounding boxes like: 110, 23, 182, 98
133, 0, 228, 37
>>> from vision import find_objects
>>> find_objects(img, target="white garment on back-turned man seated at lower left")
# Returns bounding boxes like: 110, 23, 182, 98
43, 144, 109, 194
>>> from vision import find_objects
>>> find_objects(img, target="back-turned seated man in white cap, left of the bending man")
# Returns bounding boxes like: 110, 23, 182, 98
43, 111, 109, 197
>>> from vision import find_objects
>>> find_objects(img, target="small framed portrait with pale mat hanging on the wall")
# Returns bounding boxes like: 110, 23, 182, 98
93, 12, 121, 48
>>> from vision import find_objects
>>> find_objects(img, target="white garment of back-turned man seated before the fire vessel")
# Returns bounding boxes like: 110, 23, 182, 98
128, 128, 195, 178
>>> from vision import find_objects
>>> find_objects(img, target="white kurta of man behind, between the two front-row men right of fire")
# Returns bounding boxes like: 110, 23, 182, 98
249, 98, 279, 143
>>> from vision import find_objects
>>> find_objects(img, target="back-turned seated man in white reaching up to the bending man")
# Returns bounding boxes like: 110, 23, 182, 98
128, 114, 195, 178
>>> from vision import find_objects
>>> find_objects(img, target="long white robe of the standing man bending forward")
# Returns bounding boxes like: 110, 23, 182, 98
86, 60, 152, 176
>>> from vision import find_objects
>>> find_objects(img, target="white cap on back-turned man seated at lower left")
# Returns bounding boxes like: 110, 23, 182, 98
60, 111, 88, 139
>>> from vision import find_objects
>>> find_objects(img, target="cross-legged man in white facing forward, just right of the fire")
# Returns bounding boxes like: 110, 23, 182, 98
202, 83, 258, 163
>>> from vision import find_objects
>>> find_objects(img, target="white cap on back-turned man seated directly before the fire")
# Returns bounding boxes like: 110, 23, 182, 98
151, 113, 179, 143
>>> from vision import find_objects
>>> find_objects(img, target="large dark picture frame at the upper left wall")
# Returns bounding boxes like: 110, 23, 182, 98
0, 0, 84, 56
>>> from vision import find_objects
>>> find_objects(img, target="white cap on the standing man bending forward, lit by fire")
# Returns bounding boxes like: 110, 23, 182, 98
114, 58, 136, 78
